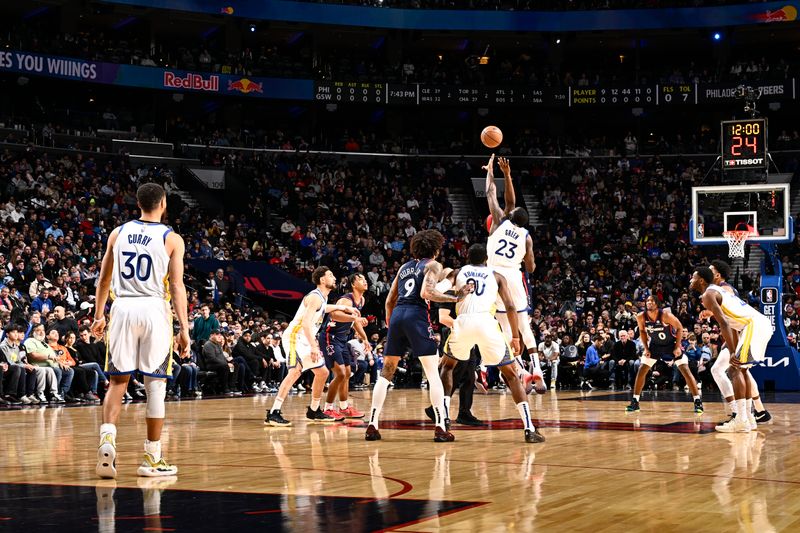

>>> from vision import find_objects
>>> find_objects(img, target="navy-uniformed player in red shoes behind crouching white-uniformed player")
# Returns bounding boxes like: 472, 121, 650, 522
319, 274, 372, 420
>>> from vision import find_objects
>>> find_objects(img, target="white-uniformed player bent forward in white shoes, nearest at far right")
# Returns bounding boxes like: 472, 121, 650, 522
690, 267, 772, 433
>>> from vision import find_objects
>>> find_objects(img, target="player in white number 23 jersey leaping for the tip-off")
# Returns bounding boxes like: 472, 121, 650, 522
483, 154, 547, 394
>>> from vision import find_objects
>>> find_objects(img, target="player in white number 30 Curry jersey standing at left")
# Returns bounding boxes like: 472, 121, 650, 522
92, 183, 190, 478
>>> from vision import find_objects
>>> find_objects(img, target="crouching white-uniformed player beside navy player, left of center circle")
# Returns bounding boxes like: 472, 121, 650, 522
264, 267, 361, 427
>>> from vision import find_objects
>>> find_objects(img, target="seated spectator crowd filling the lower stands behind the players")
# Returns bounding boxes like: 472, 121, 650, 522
0, 108, 800, 404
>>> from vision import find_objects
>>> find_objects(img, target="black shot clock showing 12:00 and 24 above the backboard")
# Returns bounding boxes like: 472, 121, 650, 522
720, 118, 767, 172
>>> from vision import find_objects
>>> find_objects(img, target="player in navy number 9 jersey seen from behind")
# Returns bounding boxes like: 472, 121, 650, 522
365, 230, 472, 442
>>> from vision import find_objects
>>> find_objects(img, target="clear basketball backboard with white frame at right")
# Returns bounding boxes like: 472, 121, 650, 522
689, 183, 794, 245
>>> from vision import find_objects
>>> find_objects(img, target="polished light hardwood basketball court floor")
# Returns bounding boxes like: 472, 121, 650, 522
0, 390, 800, 533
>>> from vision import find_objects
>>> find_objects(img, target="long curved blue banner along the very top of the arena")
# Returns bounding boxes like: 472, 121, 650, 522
102, 0, 800, 32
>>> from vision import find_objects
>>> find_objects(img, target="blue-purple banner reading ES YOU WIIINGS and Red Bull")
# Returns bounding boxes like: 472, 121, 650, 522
0, 50, 314, 100
